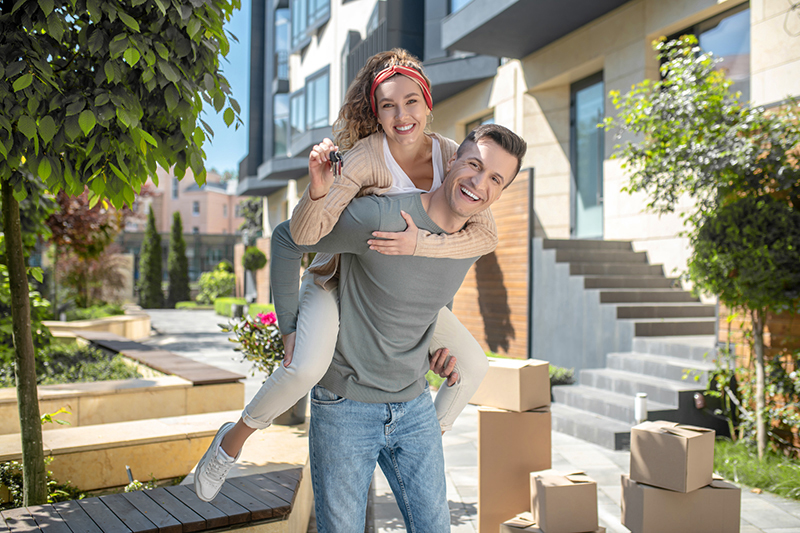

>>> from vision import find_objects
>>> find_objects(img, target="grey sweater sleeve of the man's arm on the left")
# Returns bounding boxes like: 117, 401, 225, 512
270, 197, 381, 335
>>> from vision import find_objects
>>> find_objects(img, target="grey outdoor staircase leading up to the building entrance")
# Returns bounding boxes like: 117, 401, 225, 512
542, 239, 717, 450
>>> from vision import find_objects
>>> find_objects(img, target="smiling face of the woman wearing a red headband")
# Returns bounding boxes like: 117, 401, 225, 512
375, 74, 431, 145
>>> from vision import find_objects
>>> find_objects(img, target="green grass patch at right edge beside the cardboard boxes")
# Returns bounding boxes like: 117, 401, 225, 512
714, 439, 800, 500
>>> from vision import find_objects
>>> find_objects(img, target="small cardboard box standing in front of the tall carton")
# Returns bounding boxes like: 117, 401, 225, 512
530, 470, 598, 533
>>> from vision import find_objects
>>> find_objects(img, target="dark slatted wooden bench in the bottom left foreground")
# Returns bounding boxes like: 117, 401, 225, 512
0, 468, 311, 533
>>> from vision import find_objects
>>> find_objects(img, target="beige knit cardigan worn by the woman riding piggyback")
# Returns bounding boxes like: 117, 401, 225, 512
290, 133, 497, 285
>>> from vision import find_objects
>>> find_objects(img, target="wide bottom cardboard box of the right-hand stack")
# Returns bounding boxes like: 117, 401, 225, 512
622, 474, 742, 533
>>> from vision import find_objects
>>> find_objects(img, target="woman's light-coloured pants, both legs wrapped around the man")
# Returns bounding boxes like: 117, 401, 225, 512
242, 274, 489, 431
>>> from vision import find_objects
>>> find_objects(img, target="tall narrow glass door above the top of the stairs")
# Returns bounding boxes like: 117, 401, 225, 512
570, 72, 605, 239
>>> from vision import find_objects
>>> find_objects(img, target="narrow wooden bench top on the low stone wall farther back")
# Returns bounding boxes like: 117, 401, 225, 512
75, 331, 245, 385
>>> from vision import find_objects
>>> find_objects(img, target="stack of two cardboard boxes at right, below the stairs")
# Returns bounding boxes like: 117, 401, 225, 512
622, 422, 741, 533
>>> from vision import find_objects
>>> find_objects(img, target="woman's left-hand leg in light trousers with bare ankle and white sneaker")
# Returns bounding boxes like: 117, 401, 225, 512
195, 274, 339, 501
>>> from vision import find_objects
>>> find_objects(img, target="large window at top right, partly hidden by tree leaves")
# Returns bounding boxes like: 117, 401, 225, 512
670, 3, 750, 102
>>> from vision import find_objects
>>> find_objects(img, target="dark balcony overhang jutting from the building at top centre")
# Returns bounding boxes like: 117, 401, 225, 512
442, 0, 628, 59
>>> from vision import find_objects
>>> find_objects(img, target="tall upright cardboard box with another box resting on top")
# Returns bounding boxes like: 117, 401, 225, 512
478, 407, 551, 533
